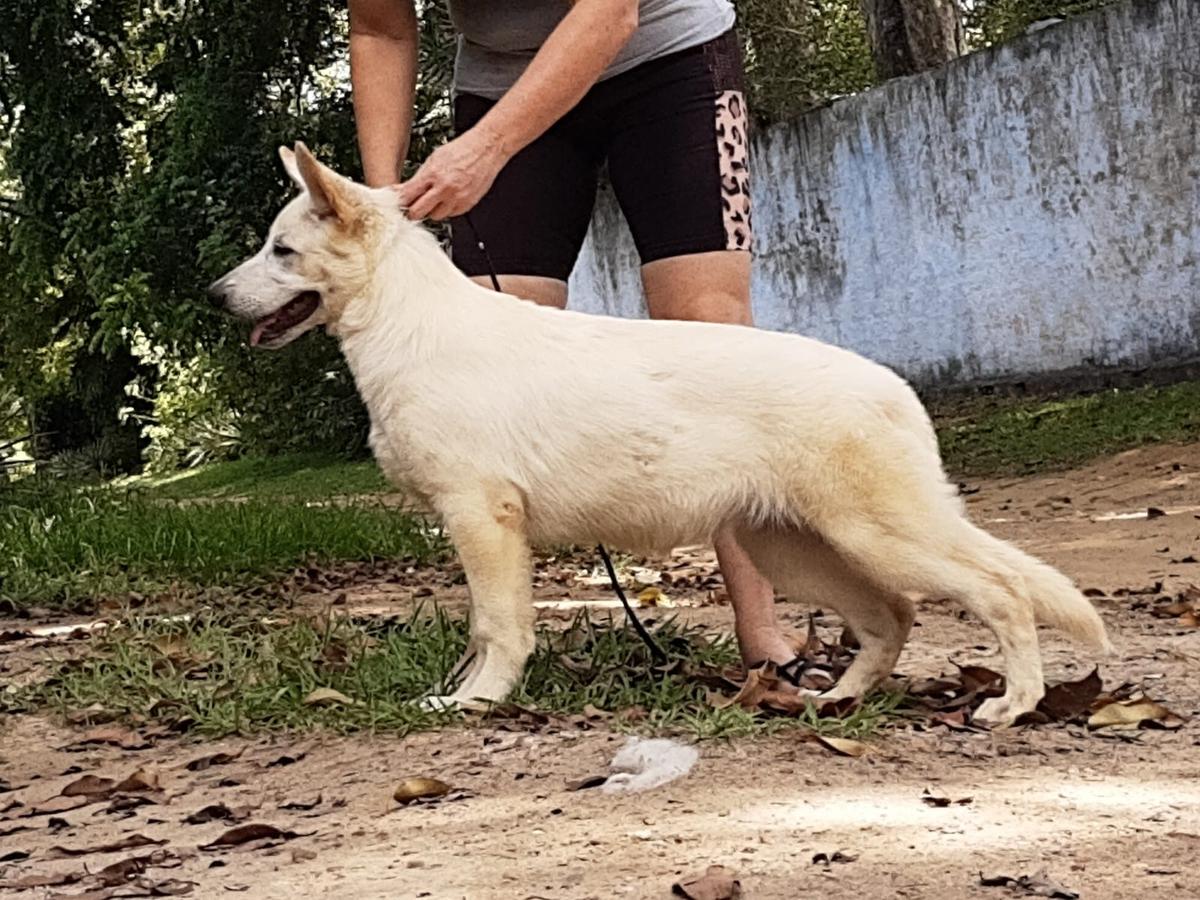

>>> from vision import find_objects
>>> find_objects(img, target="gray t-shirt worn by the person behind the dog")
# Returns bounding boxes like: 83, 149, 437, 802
449, 0, 734, 100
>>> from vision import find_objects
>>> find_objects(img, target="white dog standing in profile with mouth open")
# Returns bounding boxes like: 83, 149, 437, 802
204, 144, 1109, 724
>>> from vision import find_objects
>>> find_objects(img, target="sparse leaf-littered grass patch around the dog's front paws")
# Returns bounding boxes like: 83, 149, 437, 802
17, 611, 896, 738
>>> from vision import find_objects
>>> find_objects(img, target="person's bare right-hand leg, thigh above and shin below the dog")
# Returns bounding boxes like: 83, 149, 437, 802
642, 250, 796, 664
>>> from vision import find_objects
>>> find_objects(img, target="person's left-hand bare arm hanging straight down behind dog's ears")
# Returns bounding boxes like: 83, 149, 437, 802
349, 0, 418, 187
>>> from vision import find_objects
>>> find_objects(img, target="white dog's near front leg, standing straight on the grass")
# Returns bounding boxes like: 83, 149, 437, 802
426, 484, 535, 707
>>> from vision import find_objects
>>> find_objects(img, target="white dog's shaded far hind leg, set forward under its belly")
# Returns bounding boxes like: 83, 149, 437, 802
742, 529, 914, 700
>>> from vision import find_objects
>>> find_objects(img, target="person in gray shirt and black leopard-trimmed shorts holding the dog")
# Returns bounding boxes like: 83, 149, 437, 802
349, 0, 794, 665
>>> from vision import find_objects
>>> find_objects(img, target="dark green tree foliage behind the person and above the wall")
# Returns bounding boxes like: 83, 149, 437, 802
0, 0, 1128, 478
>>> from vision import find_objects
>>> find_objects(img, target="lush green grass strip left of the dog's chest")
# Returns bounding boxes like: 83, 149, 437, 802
0, 482, 439, 606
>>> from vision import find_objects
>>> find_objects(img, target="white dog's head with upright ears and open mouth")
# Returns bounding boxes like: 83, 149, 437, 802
209, 143, 379, 349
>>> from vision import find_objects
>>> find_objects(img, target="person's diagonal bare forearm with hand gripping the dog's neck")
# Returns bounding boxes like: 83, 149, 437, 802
398, 0, 637, 218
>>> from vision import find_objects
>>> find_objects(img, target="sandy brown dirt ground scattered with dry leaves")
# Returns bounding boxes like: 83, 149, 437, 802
0, 444, 1200, 900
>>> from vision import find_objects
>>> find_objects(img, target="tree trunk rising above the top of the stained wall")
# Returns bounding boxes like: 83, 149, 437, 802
860, 0, 962, 79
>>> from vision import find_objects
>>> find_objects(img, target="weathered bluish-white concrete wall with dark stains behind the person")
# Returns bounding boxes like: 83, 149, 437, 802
571, 0, 1200, 384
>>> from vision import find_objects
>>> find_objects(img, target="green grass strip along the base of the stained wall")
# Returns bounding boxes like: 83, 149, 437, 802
935, 382, 1200, 476
